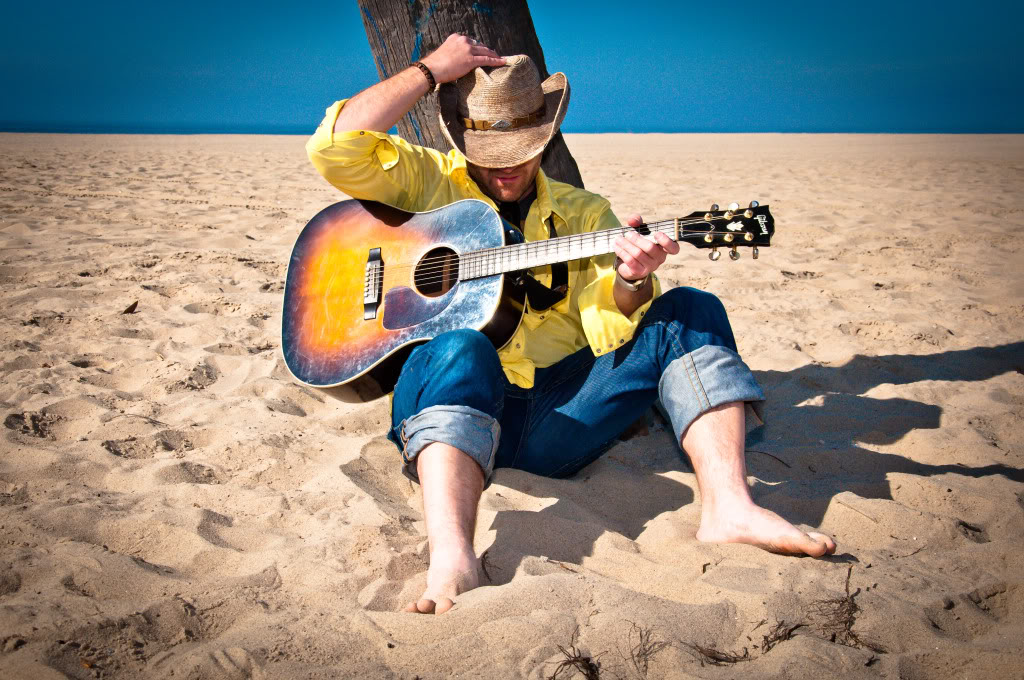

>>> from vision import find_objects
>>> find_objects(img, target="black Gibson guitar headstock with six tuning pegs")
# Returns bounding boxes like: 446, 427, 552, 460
679, 201, 775, 260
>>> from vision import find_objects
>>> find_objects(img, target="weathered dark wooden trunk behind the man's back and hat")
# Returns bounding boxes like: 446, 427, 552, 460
358, 0, 583, 187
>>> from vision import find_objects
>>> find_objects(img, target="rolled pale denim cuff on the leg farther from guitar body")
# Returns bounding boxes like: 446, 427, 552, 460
657, 345, 765, 441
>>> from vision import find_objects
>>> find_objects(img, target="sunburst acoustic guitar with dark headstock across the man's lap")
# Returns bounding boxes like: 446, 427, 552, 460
282, 199, 775, 396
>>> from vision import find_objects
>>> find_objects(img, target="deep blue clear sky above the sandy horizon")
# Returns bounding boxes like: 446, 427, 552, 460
0, 0, 1024, 133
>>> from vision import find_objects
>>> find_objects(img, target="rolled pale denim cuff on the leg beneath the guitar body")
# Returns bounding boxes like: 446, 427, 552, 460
398, 406, 501, 485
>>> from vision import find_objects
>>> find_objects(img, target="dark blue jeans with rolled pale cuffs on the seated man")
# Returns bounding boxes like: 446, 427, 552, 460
388, 288, 764, 482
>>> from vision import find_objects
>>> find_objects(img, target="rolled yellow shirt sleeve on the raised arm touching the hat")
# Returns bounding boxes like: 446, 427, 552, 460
306, 99, 453, 211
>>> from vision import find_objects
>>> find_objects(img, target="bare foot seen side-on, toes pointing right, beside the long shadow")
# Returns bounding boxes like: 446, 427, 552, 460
697, 503, 836, 557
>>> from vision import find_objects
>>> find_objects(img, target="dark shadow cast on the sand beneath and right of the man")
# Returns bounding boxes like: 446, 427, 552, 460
481, 342, 1024, 584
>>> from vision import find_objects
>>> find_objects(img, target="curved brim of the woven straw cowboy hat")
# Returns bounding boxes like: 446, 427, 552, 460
437, 73, 569, 168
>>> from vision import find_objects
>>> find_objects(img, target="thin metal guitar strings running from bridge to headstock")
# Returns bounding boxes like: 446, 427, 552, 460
366, 216, 765, 286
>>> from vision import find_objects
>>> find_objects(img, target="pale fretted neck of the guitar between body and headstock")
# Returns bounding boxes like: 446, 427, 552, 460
459, 219, 684, 280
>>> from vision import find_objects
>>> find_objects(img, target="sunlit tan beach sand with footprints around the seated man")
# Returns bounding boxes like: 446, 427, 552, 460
0, 134, 1024, 679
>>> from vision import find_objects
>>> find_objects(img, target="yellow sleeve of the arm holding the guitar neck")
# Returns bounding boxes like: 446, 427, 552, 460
579, 203, 662, 355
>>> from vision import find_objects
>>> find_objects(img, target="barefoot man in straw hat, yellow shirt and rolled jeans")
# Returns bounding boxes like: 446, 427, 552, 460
306, 35, 836, 613
